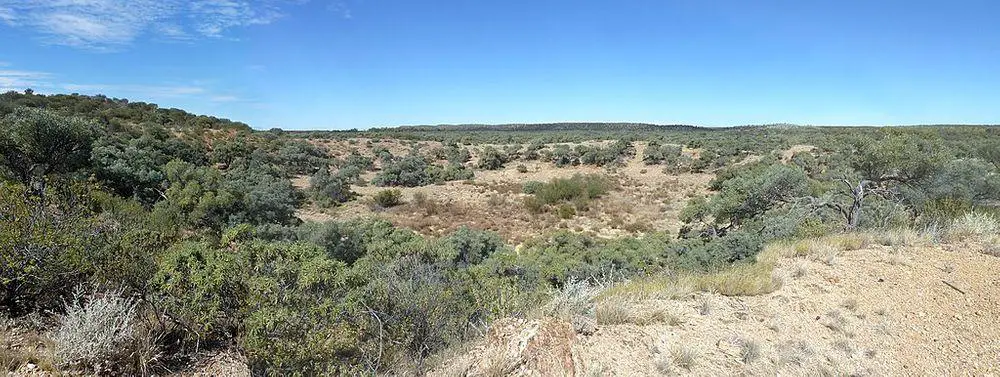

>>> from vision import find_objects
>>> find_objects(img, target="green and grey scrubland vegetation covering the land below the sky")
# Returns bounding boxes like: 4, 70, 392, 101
0, 92, 1000, 375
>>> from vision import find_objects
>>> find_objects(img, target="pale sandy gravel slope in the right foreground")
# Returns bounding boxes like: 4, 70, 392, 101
441, 236, 1000, 376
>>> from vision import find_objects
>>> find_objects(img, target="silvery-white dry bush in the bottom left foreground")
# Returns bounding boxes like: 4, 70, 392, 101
52, 290, 150, 374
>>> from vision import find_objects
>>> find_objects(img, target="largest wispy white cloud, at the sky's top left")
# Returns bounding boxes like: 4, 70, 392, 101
0, 0, 293, 50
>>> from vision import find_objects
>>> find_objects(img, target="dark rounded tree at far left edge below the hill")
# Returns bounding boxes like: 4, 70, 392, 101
0, 108, 94, 194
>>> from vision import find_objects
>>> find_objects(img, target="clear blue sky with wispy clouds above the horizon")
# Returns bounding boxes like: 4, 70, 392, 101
0, 0, 1000, 129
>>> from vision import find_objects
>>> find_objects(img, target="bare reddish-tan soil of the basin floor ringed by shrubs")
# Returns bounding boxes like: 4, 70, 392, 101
293, 141, 713, 243
